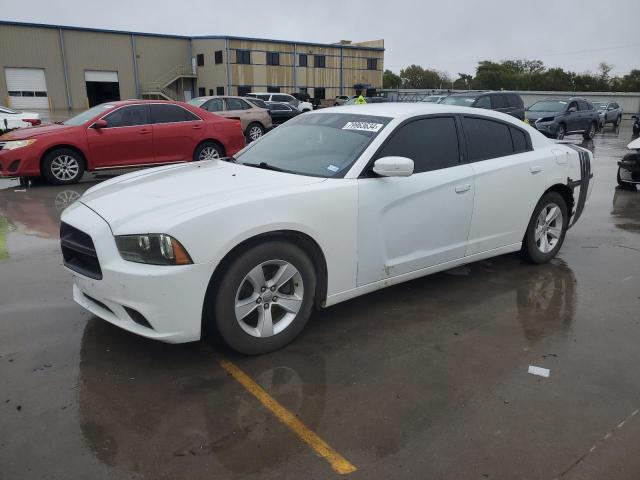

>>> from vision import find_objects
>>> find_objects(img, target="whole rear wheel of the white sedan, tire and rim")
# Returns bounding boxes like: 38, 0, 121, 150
521, 192, 569, 264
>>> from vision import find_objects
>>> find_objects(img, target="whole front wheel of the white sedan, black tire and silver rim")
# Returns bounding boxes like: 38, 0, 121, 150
211, 240, 316, 355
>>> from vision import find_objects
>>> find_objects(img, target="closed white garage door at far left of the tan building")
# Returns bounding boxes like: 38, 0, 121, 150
4, 68, 49, 110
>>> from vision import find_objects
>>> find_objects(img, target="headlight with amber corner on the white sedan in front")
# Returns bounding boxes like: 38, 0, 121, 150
116, 233, 193, 265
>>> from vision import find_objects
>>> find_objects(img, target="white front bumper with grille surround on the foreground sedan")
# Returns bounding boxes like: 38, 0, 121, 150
61, 202, 214, 343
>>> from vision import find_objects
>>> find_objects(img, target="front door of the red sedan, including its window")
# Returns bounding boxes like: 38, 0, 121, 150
87, 104, 155, 168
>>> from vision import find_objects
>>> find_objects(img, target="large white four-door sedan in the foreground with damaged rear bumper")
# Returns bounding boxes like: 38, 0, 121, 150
61, 103, 593, 354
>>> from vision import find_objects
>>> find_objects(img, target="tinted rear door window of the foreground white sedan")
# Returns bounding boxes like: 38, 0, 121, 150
462, 117, 513, 162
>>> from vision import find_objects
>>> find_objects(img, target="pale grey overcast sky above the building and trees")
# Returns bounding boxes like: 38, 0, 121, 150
0, 0, 640, 79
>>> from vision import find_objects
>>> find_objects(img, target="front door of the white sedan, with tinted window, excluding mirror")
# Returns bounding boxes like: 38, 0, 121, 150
357, 116, 475, 286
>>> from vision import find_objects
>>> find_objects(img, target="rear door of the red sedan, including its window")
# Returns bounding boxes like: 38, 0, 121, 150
149, 103, 204, 163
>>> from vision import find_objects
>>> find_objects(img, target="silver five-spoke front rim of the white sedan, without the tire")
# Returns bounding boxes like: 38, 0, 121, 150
234, 260, 304, 338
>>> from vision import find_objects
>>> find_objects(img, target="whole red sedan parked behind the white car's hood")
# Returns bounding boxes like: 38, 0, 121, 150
0, 100, 245, 185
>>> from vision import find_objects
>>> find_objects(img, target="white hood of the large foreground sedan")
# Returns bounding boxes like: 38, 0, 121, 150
80, 160, 326, 234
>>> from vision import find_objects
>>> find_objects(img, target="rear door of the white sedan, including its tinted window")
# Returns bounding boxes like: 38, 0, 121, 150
462, 115, 552, 255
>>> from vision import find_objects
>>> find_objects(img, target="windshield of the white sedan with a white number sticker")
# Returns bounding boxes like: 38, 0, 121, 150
236, 113, 391, 178
